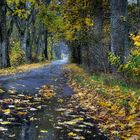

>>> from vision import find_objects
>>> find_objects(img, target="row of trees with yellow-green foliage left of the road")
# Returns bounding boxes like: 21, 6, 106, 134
0, 0, 62, 68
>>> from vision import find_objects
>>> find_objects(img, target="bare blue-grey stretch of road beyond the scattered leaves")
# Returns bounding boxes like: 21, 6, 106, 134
0, 59, 72, 96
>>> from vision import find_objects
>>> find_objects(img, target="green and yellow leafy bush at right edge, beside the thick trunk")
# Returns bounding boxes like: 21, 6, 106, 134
108, 33, 140, 83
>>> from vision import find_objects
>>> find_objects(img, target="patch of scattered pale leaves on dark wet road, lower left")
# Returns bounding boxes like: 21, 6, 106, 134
0, 85, 55, 132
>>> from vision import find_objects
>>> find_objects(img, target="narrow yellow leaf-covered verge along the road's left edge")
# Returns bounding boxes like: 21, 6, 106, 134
0, 61, 50, 76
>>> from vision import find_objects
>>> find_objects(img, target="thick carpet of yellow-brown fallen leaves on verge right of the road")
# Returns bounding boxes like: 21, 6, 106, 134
65, 64, 140, 140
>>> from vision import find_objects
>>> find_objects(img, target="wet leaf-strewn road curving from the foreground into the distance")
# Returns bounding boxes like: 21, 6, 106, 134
0, 59, 107, 140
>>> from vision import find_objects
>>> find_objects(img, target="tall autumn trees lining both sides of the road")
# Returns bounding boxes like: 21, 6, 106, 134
0, 0, 140, 81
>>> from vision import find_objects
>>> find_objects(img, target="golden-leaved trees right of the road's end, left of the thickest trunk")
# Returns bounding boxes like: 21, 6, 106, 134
63, 0, 109, 71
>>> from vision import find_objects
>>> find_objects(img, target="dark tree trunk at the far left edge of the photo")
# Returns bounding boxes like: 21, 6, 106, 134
0, 0, 10, 68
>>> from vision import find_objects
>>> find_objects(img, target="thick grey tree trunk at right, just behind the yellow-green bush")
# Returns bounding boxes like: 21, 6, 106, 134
110, 0, 128, 64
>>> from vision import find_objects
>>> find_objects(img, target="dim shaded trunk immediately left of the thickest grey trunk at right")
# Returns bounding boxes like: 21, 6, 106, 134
90, 0, 107, 72
